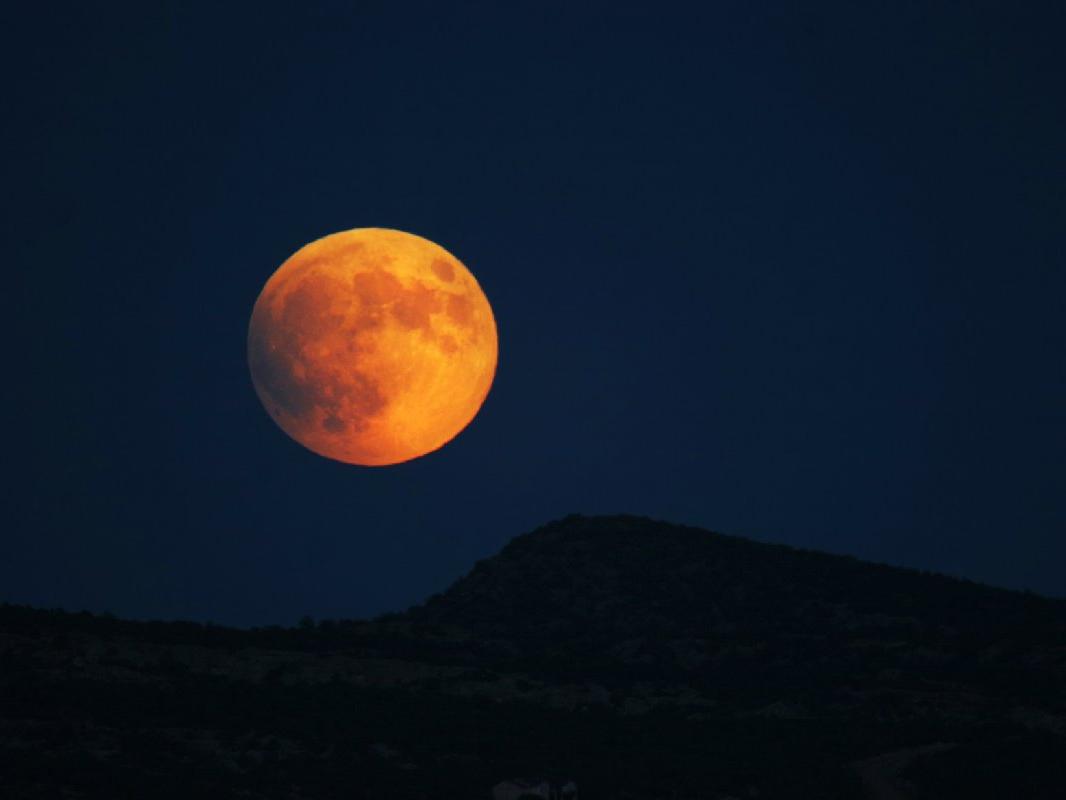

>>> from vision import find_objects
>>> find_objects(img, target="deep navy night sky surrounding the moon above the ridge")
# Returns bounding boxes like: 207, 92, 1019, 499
8, 0, 1066, 625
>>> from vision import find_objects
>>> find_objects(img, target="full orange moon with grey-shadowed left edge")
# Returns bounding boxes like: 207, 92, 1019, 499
248, 228, 497, 466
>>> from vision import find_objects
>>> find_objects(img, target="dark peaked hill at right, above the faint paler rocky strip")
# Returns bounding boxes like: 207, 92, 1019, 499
407, 516, 1066, 701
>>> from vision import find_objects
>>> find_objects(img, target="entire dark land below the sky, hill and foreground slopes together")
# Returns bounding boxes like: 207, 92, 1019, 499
0, 516, 1066, 800
